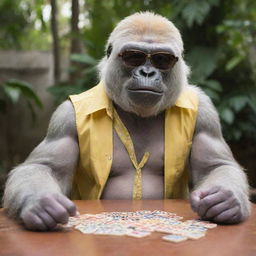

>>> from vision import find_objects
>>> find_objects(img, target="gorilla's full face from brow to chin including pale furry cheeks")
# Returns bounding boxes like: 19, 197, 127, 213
105, 42, 185, 117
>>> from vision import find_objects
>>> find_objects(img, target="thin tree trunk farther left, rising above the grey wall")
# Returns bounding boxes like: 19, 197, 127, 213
51, 0, 60, 84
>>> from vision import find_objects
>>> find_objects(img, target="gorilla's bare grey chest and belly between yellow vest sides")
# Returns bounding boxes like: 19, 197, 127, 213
102, 114, 164, 199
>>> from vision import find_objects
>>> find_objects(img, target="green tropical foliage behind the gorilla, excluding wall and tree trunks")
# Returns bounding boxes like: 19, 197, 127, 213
0, 0, 256, 140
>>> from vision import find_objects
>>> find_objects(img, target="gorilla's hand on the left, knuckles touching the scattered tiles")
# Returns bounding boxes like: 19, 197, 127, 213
21, 194, 76, 231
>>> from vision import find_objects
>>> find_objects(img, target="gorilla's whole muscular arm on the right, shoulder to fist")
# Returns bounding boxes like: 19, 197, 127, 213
189, 88, 250, 224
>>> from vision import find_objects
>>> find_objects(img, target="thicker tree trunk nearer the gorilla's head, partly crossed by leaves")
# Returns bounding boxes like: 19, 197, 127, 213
70, 0, 82, 82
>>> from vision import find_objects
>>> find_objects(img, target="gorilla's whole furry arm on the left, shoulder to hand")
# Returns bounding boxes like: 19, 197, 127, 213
4, 101, 79, 230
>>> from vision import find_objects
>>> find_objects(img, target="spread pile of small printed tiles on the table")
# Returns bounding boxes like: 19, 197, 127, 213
65, 210, 217, 243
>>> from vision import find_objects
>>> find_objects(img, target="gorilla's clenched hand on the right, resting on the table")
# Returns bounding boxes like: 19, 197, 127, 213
190, 186, 242, 224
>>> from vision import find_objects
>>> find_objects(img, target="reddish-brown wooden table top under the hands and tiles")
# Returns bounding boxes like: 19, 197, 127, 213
0, 200, 256, 256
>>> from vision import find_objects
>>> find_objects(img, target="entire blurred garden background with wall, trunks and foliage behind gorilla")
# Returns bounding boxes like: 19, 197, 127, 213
0, 0, 256, 204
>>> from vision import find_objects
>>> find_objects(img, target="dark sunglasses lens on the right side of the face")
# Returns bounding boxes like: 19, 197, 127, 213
151, 53, 177, 70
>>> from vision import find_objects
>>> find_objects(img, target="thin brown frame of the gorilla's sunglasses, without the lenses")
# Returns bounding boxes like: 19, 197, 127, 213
118, 49, 179, 71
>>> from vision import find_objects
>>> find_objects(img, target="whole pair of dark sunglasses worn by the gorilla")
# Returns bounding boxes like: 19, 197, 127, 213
118, 50, 179, 70
